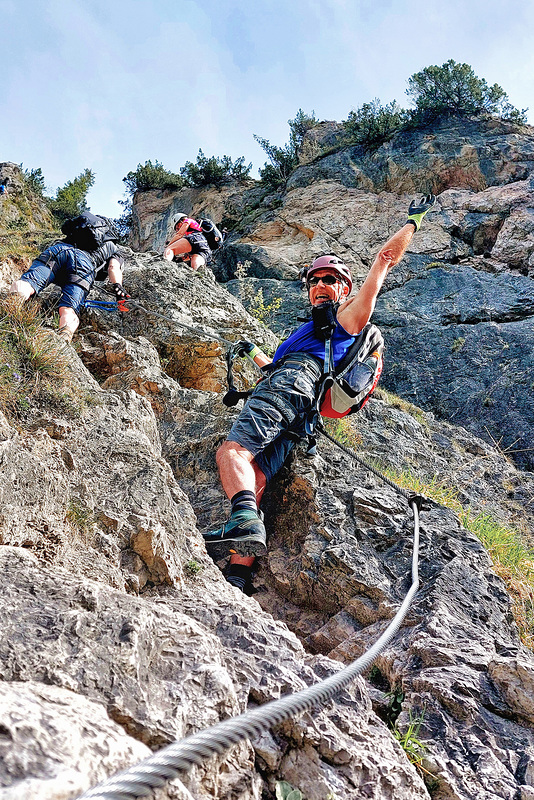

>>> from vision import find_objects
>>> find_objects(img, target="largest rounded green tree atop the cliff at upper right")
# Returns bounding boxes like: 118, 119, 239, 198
406, 59, 528, 123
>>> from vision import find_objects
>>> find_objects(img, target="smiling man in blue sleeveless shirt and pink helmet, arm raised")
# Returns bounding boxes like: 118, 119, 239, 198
204, 195, 435, 589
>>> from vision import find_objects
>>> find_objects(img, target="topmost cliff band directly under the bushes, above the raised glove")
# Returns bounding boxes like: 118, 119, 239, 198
288, 119, 534, 194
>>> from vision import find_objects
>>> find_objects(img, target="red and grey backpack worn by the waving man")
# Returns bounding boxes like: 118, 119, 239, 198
319, 324, 384, 419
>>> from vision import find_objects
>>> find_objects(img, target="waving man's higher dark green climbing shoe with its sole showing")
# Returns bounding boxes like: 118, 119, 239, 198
203, 508, 267, 560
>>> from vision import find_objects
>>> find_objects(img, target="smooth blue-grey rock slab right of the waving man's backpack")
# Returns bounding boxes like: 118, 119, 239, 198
375, 267, 534, 470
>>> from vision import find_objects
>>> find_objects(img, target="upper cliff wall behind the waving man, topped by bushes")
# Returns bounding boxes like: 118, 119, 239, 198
133, 120, 534, 470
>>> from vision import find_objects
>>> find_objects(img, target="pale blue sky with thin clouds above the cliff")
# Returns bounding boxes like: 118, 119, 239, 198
0, 0, 534, 216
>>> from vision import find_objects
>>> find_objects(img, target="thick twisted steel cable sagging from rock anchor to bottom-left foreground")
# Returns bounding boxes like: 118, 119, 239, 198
78, 500, 419, 800
